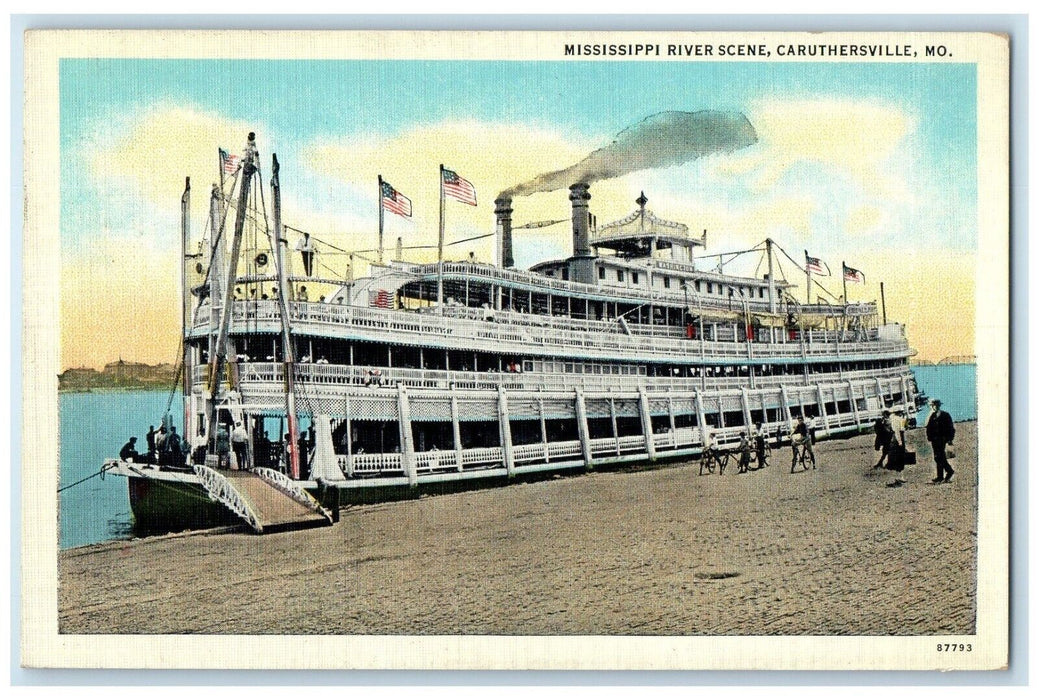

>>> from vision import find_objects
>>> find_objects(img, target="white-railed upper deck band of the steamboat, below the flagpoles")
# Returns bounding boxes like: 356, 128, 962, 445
189, 300, 911, 365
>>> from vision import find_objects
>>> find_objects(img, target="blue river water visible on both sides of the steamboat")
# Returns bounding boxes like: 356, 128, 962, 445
58, 365, 978, 549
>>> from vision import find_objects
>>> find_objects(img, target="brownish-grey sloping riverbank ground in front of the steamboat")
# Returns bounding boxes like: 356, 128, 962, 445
58, 423, 978, 635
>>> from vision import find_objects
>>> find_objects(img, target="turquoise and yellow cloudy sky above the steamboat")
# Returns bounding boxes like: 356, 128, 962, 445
59, 59, 978, 368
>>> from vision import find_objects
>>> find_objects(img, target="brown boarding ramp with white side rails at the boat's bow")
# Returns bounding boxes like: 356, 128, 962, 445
194, 465, 332, 533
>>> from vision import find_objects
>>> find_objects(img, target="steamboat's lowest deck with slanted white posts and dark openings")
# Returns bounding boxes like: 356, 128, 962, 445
187, 372, 918, 487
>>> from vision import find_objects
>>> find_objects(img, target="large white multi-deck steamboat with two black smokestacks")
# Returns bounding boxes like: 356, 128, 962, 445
105, 128, 920, 531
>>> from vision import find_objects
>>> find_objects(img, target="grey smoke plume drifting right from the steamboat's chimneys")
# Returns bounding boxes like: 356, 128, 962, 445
499, 110, 757, 197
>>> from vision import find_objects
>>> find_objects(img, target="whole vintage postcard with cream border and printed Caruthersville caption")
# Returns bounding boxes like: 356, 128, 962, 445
22, 31, 1009, 670
